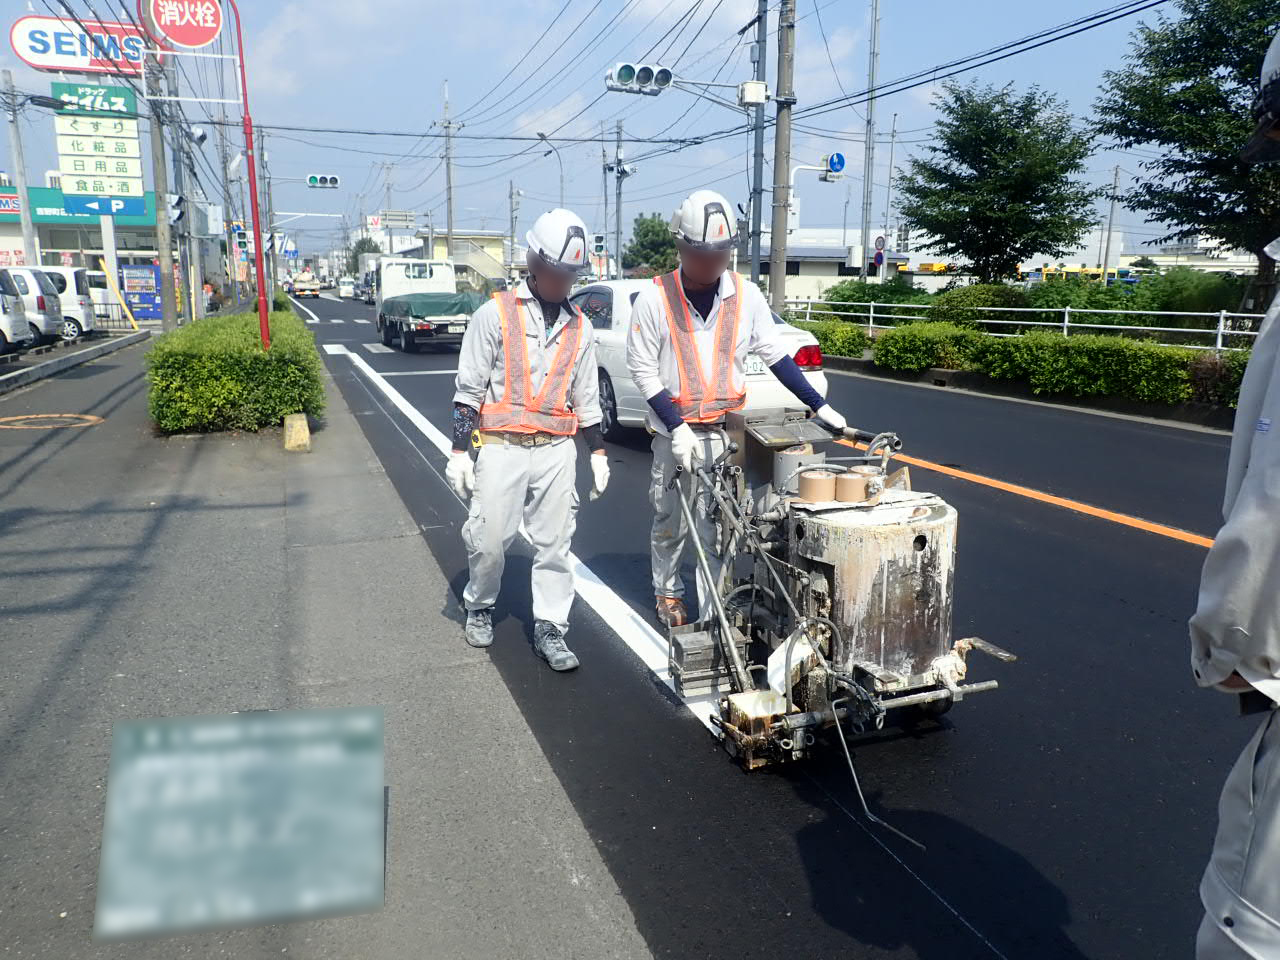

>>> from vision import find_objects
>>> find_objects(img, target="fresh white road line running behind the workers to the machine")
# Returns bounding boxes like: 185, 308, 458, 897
324, 343, 719, 736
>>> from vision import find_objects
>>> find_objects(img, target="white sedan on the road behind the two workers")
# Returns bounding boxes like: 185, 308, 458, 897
570, 280, 827, 439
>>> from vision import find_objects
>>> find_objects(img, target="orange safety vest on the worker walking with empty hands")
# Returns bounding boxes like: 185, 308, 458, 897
480, 291, 582, 436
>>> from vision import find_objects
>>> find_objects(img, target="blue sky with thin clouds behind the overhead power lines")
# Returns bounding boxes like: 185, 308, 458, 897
3, 0, 1172, 251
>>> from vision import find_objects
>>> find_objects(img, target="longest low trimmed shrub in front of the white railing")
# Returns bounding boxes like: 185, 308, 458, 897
979, 332, 1194, 403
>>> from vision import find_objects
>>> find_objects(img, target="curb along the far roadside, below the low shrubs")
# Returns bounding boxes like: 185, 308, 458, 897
822, 356, 1235, 433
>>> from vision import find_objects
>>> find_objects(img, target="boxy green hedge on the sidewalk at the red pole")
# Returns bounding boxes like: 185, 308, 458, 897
146, 310, 324, 433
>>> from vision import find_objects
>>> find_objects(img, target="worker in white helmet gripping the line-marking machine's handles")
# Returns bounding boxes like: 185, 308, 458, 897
627, 189, 846, 627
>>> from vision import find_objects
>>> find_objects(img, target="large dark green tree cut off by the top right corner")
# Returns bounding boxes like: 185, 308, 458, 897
1097, 0, 1280, 296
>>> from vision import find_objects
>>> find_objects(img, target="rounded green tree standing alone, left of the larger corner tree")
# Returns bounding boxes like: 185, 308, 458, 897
897, 83, 1098, 283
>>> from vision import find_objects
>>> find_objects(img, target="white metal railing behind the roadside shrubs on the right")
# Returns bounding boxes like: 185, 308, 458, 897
787, 300, 1262, 352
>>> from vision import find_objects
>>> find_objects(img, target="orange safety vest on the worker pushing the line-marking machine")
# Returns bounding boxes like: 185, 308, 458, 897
654, 271, 746, 424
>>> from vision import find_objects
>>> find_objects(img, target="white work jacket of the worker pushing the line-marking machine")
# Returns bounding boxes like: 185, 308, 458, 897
627, 270, 791, 434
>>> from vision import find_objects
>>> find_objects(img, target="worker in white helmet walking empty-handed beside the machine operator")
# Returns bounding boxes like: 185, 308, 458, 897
447, 210, 609, 671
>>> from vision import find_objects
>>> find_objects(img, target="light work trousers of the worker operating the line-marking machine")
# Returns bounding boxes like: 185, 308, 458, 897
649, 430, 726, 618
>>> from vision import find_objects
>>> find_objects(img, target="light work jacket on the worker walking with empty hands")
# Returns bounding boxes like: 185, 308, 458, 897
453, 280, 600, 428
